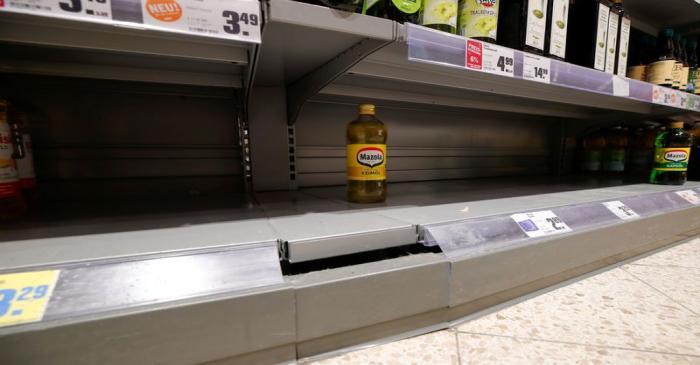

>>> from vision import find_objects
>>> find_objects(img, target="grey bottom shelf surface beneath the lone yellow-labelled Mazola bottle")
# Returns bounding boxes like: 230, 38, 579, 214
5, 176, 700, 268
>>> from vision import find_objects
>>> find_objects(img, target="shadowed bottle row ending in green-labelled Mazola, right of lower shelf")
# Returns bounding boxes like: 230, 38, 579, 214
579, 121, 700, 185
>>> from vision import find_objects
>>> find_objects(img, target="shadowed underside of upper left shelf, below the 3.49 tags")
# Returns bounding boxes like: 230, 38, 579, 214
0, 12, 255, 88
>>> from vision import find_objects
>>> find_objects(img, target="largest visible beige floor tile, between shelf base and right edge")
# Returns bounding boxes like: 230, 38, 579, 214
458, 268, 700, 355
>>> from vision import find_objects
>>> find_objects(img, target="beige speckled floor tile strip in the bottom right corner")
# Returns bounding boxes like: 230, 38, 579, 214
459, 333, 700, 365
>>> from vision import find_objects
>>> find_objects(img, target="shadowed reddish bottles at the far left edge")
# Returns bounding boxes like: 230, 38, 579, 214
0, 99, 36, 220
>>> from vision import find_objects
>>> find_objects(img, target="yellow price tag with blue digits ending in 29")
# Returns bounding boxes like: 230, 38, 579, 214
0, 270, 60, 327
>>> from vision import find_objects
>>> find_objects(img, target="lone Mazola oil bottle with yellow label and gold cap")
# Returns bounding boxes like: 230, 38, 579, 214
346, 104, 387, 203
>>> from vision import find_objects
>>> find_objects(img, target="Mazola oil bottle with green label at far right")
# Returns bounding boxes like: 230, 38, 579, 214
649, 121, 692, 185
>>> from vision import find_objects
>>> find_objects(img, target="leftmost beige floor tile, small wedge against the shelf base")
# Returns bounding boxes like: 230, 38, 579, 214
310, 331, 459, 365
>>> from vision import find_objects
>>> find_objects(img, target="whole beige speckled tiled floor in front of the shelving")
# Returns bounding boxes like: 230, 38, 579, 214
304, 238, 700, 365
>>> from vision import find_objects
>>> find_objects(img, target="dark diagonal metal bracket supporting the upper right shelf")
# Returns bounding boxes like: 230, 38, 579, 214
287, 38, 393, 125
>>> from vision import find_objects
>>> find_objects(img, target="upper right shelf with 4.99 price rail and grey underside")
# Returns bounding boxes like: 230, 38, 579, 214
317, 24, 700, 120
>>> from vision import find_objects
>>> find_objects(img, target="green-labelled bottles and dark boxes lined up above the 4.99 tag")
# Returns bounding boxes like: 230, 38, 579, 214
306, 0, 631, 75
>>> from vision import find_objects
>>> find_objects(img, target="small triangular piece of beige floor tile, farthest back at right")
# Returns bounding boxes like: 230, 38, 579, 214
623, 264, 700, 314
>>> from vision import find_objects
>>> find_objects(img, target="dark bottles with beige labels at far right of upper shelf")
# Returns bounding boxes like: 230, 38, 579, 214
627, 28, 700, 94
